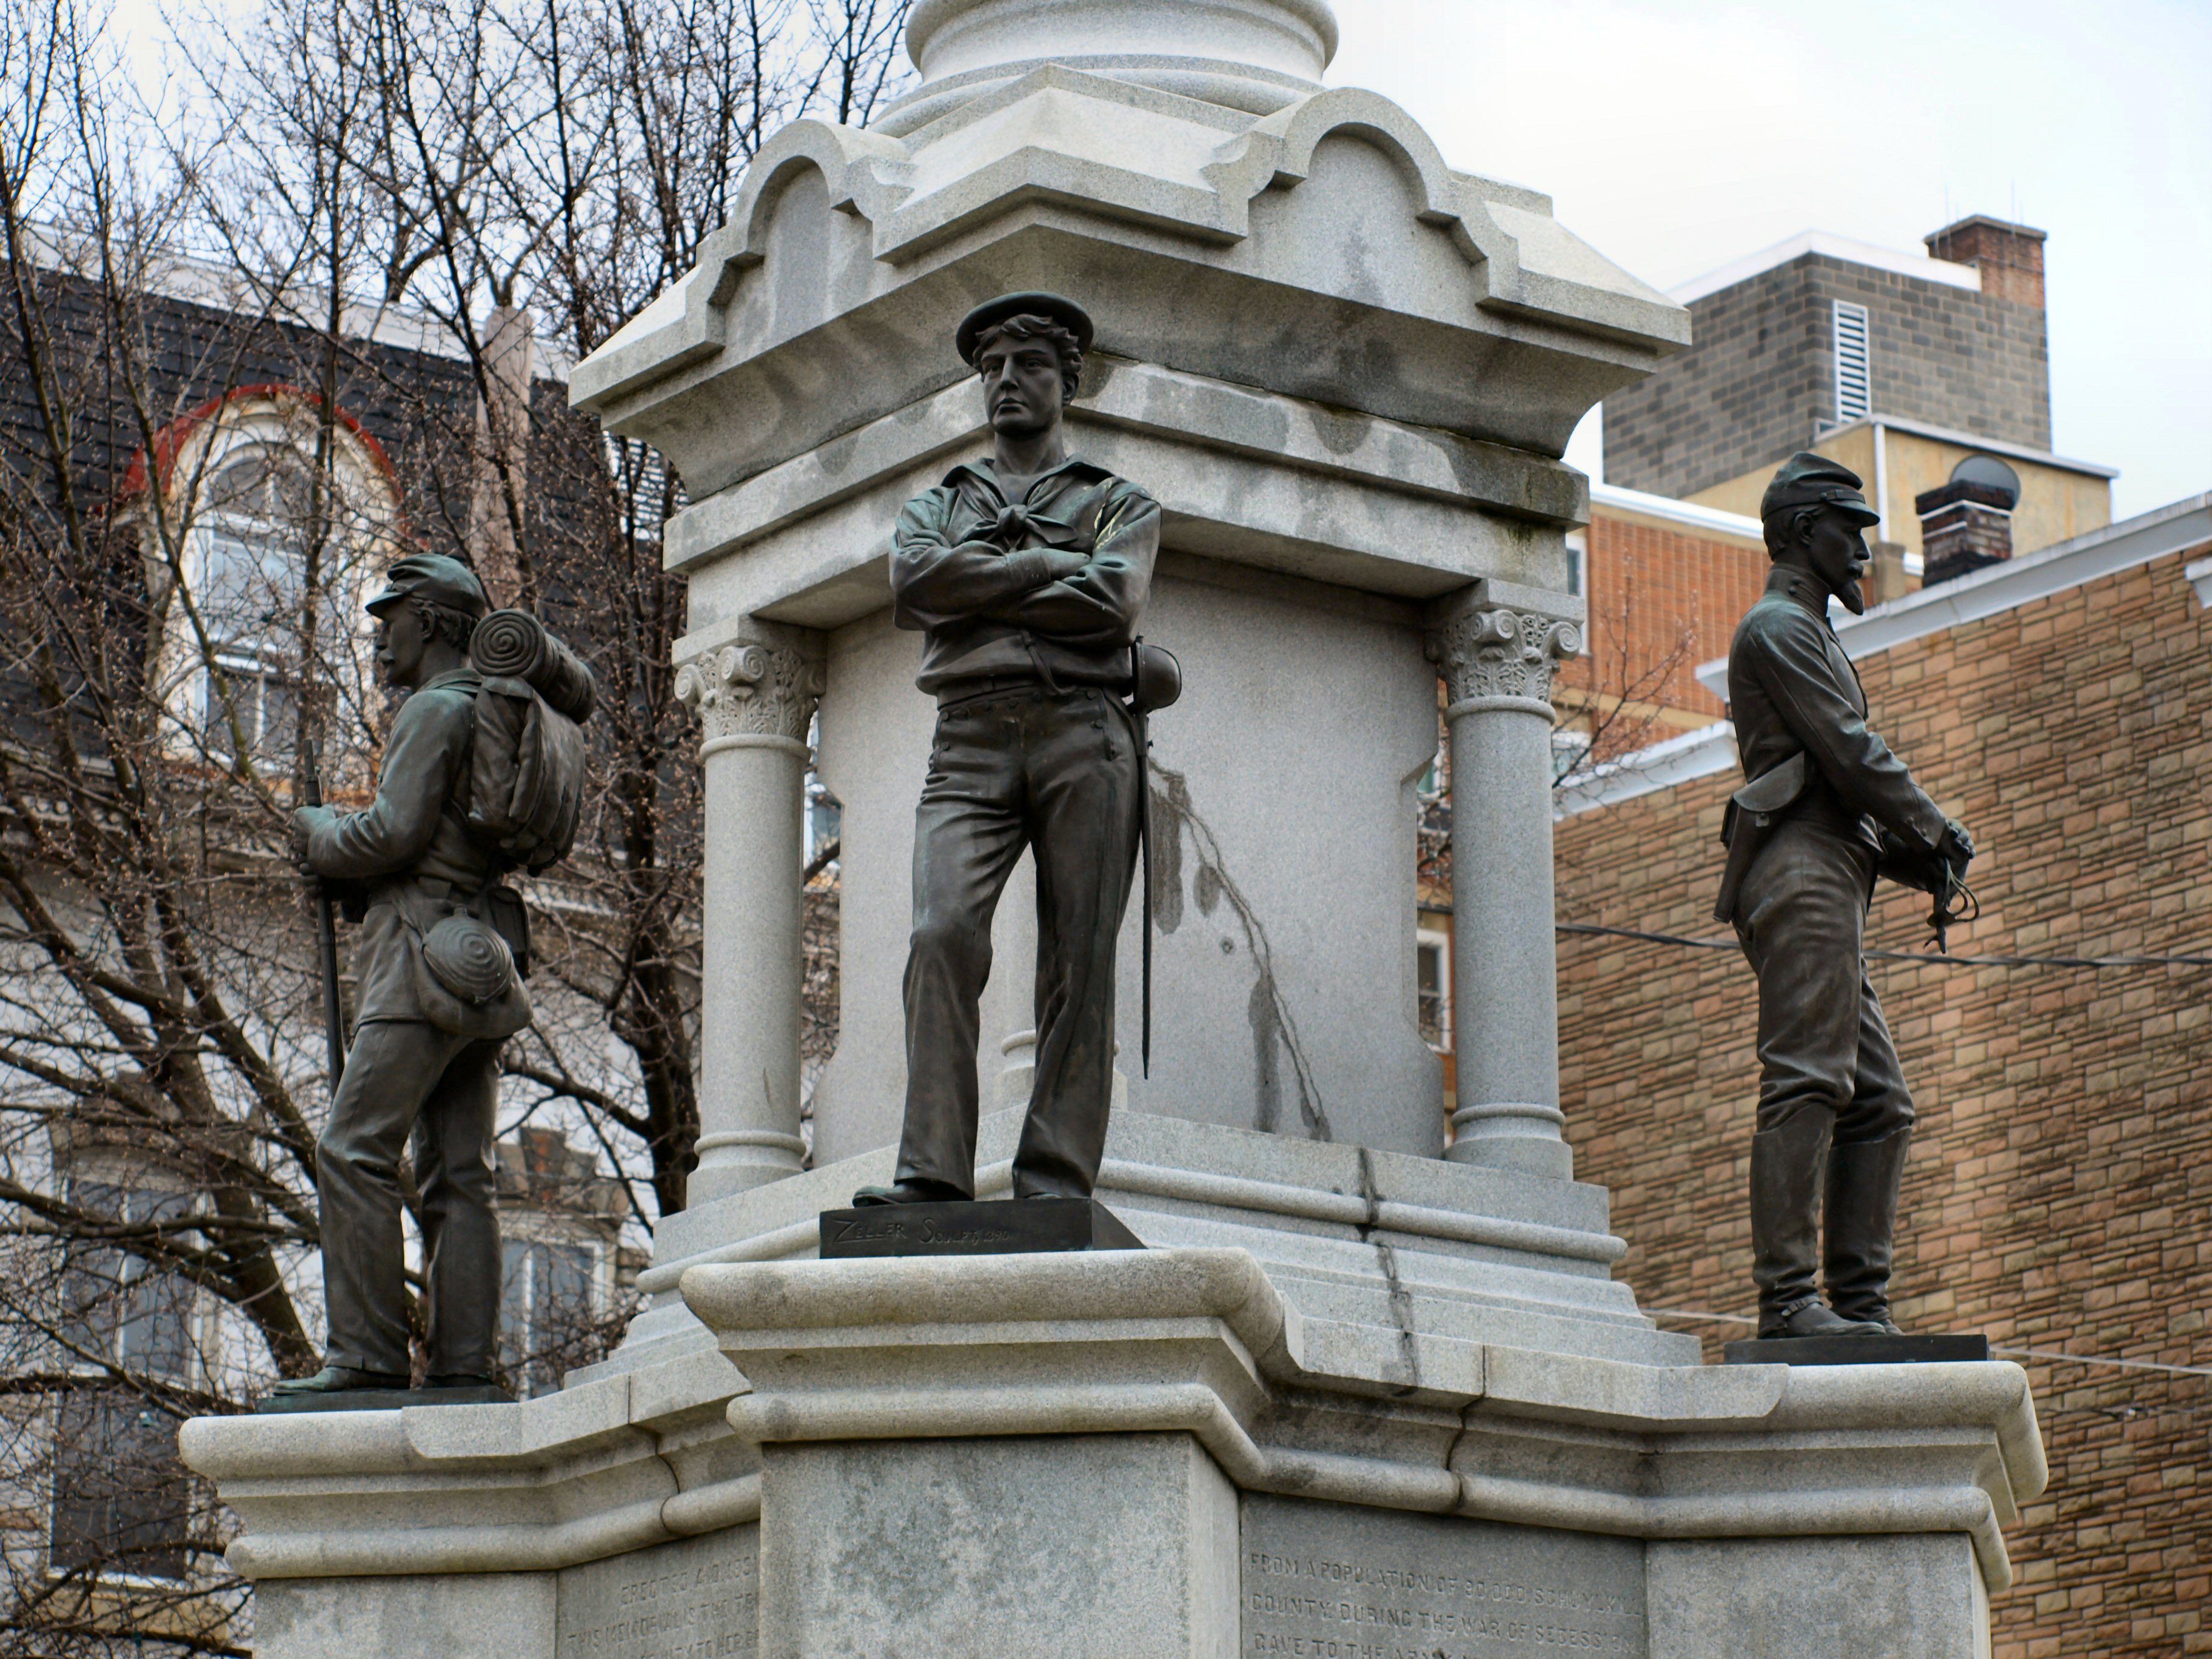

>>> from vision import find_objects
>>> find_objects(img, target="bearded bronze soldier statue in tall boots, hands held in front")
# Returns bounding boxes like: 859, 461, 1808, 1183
1714, 454, 1973, 1338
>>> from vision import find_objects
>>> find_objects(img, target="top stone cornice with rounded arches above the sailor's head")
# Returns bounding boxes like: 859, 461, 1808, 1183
571, 64, 1687, 486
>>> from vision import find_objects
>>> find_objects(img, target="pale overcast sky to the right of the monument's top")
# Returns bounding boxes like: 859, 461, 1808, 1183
1329, 0, 2212, 518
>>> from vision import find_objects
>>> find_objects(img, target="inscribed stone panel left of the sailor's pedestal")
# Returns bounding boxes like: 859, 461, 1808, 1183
553, 1526, 761, 1659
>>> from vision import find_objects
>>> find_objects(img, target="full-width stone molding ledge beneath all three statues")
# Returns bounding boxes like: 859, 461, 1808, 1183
181, 1250, 2048, 1588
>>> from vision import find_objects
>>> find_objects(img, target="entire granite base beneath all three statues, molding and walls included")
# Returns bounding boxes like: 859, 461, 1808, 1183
179, 1247, 2046, 1659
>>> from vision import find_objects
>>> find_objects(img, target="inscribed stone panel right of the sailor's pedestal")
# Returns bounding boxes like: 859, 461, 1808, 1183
1241, 1493, 1646, 1659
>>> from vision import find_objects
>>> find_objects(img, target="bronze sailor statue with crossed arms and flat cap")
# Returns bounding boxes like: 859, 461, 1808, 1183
854, 294, 1159, 1205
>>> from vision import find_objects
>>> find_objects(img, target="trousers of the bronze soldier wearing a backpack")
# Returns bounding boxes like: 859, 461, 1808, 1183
314, 1020, 500, 1376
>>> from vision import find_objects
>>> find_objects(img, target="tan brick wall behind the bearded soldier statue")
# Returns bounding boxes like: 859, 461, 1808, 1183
1557, 549, 2212, 1659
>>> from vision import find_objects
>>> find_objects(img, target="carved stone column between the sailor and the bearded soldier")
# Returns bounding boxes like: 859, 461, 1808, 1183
1429, 580, 1581, 1181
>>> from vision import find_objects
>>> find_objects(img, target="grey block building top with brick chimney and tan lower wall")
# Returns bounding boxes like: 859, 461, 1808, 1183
1604, 217, 2114, 571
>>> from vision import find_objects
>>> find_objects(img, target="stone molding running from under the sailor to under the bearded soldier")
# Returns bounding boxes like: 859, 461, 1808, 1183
683, 1250, 2048, 1590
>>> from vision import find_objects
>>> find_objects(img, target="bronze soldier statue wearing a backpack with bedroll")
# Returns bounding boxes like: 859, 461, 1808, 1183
267, 553, 593, 1409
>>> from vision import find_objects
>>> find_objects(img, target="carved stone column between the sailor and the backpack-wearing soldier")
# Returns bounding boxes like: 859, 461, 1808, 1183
677, 619, 823, 1205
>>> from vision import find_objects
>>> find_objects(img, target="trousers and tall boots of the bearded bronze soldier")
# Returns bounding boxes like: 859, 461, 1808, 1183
1737, 819, 1914, 1318
